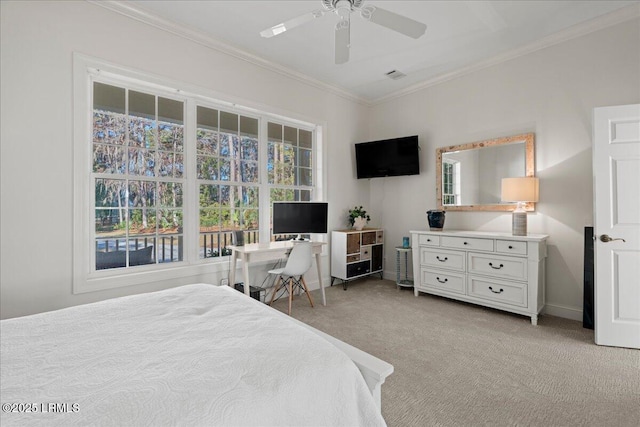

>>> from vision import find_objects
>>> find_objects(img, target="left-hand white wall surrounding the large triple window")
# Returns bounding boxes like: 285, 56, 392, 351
0, 1, 368, 318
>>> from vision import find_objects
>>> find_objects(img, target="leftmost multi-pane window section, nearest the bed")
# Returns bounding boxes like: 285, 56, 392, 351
92, 82, 184, 270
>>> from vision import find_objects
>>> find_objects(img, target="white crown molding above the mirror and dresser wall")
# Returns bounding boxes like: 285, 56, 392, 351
369, 2, 640, 106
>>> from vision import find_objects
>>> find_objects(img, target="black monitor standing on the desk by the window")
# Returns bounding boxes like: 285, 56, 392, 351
273, 202, 329, 238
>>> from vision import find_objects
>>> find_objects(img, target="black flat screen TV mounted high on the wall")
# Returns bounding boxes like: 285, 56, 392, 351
356, 135, 420, 179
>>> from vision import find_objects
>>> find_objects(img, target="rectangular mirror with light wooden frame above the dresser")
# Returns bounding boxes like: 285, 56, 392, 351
436, 133, 535, 211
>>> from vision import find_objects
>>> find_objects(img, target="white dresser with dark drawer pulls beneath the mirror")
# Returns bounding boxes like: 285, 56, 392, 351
411, 231, 548, 325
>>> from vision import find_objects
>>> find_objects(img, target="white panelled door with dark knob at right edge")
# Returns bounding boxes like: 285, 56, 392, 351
593, 105, 640, 348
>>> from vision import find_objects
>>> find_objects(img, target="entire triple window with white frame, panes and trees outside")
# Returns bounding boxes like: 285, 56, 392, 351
73, 55, 323, 293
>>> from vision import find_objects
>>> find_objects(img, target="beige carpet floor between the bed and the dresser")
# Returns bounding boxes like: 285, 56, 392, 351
274, 278, 640, 427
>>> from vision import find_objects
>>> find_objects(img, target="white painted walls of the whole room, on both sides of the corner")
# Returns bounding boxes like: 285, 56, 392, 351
0, 1, 640, 318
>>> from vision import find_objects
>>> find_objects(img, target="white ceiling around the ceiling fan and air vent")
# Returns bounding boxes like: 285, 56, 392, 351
117, 0, 640, 102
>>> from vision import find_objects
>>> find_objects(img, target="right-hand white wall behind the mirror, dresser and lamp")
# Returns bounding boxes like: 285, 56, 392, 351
370, 19, 640, 319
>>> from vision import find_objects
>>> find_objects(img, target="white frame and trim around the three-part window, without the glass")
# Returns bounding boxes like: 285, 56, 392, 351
73, 54, 326, 294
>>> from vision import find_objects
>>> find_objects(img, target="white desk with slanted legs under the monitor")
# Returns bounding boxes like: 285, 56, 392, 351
227, 240, 327, 305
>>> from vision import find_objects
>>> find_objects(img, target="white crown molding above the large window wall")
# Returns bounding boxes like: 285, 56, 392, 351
85, 0, 371, 106
